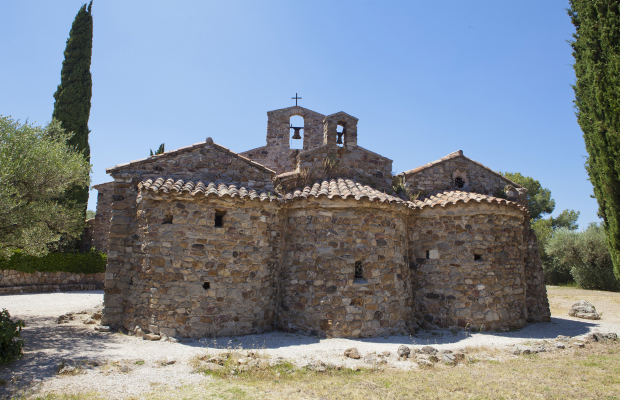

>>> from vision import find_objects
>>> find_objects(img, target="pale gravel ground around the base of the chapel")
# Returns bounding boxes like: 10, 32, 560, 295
0, 291, 620, 399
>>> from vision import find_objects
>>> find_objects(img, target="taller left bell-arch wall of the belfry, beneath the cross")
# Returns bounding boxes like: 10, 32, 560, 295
239, 107, 325, 174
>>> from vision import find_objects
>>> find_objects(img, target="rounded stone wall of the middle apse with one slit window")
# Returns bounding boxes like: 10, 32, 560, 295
277, 197, 411, 337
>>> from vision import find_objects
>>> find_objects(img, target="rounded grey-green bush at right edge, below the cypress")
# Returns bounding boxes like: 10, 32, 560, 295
545, 224, 620, 292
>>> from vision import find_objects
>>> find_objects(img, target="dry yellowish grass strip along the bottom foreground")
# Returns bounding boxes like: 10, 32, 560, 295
148, 342, 620, 400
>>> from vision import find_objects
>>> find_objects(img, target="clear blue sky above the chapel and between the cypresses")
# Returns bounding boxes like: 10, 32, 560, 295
0, 0, 598, 228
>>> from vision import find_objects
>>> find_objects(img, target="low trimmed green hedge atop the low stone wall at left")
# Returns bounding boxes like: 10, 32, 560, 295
0, 251, 108, 274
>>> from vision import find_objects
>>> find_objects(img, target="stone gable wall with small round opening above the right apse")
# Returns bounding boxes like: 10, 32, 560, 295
405, 157, 512, 196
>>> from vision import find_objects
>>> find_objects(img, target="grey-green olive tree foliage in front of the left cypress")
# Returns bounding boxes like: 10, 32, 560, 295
0, 116, 90, 256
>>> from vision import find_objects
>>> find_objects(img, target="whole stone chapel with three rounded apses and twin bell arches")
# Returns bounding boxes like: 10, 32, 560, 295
93, 106, 550, 338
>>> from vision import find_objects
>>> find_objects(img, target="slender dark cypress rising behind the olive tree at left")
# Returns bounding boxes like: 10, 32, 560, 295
52, 1, 93, 213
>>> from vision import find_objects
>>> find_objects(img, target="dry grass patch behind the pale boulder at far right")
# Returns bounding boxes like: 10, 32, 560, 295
547, 286, 620, 323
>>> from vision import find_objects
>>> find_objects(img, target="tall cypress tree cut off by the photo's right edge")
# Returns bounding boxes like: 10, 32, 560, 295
568, 0, 620, 278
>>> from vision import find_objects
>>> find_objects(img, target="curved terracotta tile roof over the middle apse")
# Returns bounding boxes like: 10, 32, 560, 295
282, 178, 406, 204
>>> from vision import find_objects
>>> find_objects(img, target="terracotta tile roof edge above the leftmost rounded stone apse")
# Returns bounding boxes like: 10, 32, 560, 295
138, 178, 276, 201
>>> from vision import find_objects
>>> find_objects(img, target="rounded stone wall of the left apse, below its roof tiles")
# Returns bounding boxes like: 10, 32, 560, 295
103, 193, 278, 337
